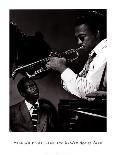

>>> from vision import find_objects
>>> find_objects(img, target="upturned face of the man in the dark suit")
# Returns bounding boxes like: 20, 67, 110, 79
24, 80, 39, 100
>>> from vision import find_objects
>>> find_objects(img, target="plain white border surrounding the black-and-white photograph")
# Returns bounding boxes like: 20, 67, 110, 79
0, 0, 116, 155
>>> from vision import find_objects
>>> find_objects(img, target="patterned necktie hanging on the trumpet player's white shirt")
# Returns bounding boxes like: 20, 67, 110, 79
79, 52, 96, 77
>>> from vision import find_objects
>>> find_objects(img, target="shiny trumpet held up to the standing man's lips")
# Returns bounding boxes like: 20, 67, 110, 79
12, 49, 79, 79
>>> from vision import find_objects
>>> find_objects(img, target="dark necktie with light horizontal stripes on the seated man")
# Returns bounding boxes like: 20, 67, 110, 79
32, 104, 38, 132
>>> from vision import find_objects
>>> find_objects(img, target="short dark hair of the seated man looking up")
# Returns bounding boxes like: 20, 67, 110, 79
17, 77, 33, 94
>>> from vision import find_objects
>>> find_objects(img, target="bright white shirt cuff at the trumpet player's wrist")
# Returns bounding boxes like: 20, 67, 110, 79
61, 68, 76, 81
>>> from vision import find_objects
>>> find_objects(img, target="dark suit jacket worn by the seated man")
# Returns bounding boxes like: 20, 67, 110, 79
10, 99, 57, 132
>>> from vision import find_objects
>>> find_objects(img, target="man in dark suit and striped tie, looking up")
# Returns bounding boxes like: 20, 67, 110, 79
10, 77, 58, 132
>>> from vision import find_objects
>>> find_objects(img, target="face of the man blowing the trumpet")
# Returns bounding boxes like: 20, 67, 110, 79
75, 24, 97, 53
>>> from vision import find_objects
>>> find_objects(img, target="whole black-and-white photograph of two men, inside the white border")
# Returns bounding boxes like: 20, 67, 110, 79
9, 9, 107, 132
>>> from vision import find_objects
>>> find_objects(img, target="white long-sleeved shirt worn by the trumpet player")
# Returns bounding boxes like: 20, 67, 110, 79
61, 39, 107, 99
